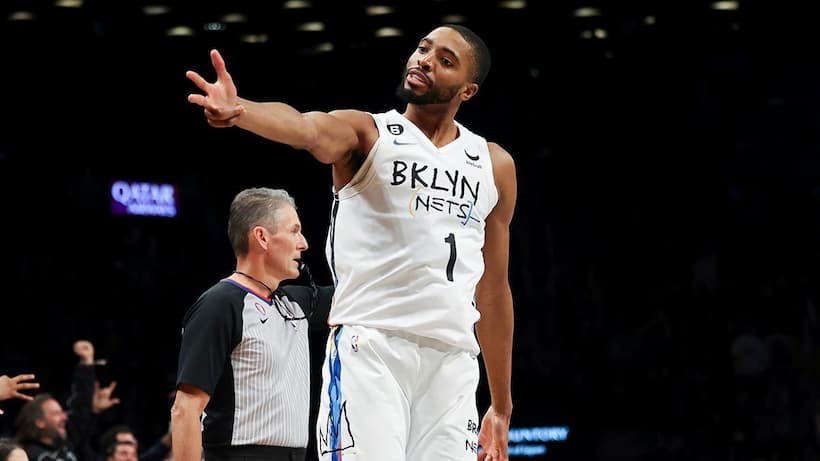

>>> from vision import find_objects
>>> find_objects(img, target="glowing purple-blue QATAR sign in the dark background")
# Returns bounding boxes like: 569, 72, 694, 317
111, 181, 177, 218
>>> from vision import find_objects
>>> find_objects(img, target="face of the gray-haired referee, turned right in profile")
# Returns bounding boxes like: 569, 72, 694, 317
268, 206, 308, 280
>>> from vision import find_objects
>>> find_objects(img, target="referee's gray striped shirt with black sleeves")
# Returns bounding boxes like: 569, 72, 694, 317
177, 279, 311, 448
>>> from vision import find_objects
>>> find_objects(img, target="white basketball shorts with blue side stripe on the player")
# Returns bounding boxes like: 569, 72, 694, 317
316, 325, 479, 461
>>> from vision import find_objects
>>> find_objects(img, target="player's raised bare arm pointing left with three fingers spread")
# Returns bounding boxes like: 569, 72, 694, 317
185, 50, 375, 165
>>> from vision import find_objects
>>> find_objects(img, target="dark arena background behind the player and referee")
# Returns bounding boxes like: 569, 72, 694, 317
0, 0, 820, 461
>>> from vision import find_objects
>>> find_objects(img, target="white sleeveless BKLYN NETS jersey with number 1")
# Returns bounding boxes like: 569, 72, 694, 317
325, 110, 498, 354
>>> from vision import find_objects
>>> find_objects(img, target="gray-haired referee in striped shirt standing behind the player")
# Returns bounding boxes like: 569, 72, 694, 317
171, 188, 331, 461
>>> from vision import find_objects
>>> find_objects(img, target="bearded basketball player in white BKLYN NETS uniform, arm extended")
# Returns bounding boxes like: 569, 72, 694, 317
187, 25, 516, 461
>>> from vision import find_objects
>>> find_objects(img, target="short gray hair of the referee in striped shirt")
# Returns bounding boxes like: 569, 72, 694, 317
228, 187, 296, 256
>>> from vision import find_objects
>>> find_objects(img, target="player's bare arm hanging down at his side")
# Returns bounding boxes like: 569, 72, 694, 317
476, 143, 516, 461
